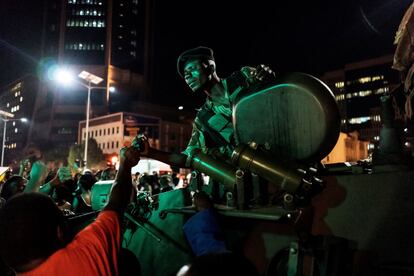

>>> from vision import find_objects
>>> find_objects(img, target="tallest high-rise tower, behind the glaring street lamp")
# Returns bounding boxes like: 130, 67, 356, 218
29, 0, 149, 154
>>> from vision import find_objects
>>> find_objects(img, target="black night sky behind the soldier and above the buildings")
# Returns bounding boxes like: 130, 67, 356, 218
0, 0, 412, 109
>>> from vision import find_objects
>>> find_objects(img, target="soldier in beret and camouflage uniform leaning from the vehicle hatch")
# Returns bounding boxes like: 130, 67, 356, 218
143, 46, 275, 201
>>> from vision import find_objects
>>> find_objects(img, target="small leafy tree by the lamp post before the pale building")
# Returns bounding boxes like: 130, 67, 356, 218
68, 138, 106, 168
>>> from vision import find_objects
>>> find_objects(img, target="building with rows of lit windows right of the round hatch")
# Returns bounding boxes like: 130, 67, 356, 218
321, 55, 400, 149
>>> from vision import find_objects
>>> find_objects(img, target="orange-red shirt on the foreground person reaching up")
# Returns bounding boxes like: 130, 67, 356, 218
20, 211, 121, 276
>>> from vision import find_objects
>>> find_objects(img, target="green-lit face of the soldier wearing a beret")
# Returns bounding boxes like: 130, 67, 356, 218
184, 60, 209, 92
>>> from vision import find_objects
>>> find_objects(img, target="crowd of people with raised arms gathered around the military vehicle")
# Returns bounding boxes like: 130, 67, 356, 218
0, 141, 258, 275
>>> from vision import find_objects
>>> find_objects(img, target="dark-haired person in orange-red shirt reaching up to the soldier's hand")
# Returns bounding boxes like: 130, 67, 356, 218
0, 140, 140, 275
